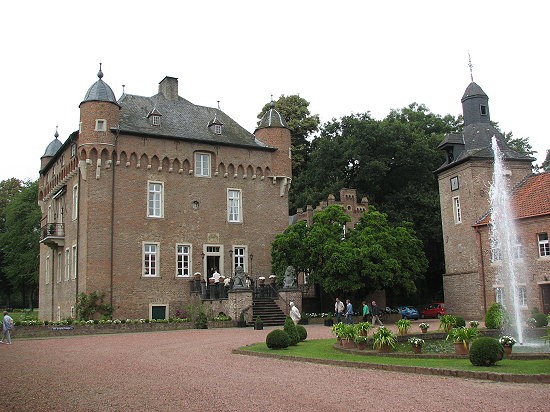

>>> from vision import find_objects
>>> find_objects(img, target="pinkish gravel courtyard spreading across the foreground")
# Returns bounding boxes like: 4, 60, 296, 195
0, 325, 550, 412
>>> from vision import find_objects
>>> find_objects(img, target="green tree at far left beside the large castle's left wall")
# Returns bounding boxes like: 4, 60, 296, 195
0, 181, 41, 308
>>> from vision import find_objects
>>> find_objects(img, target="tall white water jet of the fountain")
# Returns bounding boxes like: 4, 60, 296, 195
489, 136, 523, 344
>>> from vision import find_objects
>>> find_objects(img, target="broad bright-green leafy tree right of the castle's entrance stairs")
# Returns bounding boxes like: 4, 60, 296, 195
272, 205, 428, 296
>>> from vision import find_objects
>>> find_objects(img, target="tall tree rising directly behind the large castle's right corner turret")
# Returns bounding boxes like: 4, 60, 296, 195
258, 94, 320, 181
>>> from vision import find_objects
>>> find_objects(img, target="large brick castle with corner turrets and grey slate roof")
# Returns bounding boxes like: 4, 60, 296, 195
39, 68, 292, 320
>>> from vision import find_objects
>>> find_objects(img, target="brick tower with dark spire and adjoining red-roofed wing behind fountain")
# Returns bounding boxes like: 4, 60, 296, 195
436, 81, 550, 319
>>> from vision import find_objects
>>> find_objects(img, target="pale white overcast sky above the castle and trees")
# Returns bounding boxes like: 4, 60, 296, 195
0, 0, 550, 180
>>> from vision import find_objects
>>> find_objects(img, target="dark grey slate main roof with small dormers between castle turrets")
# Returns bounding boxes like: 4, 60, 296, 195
118, 93, 276, 151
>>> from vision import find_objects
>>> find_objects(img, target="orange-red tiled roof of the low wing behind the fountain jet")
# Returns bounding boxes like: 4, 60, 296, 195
474, 172, 550, 226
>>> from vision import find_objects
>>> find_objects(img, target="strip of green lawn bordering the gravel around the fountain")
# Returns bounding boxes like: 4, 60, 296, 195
245, 339, 550, 375
